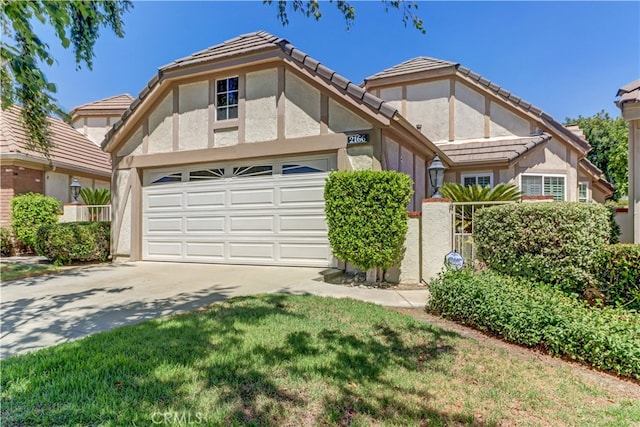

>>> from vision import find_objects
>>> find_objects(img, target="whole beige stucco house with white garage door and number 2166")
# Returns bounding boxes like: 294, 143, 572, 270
102, 32, 612, 266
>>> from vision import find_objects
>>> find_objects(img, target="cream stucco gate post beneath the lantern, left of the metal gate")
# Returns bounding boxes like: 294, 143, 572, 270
422, 199, 453, 283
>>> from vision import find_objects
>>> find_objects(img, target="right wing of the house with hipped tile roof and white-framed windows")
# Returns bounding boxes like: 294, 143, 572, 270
364, 57, 613, 202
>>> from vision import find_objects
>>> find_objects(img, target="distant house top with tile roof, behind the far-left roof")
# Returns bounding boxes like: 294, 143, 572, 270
69, 93, 133, 146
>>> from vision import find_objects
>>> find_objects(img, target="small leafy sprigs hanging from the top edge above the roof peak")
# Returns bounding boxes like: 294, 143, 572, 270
262, 0, 426, 34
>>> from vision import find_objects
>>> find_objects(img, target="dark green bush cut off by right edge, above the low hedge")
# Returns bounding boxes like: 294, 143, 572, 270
590, 244, 640, 311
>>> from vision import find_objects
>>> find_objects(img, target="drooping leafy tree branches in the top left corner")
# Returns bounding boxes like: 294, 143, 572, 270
0, 0, 132, 157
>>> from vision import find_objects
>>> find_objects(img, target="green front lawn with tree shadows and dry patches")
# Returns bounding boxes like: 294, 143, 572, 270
0, 295, 640, 426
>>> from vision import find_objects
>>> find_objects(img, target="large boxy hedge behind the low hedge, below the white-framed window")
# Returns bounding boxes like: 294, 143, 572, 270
473, 203, 610, 293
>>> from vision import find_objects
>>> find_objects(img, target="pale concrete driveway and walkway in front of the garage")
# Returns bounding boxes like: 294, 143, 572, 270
0, 260, 428, 358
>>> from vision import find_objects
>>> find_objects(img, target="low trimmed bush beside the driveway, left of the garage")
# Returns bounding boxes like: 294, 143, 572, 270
36, 222, 111, 265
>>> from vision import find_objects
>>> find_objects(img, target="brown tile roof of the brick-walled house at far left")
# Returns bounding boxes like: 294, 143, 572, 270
0, 106, 111, 176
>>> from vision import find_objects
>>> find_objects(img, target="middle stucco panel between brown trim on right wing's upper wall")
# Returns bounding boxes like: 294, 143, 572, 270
454, 82, 485, 140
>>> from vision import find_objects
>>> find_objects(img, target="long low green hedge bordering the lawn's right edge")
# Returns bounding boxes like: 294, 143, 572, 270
427, 270, 640, 379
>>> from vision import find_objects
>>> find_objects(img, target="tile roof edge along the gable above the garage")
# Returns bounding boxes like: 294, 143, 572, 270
102, 31, 397, 148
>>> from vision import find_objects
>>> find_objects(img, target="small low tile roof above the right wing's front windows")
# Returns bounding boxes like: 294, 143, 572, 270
438, 133, 551, 164
